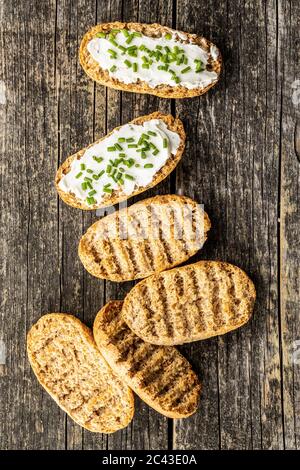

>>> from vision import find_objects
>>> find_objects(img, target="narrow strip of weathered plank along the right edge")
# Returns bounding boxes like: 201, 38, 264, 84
278, 1, 300, 449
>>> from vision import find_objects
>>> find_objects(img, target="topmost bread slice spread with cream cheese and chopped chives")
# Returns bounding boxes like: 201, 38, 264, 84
79, 21, 222, 98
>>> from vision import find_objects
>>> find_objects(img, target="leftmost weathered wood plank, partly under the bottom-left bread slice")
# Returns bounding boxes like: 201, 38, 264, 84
0, 0, 65, 449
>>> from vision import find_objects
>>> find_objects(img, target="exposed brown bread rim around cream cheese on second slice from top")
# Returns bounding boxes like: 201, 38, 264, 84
55, 111, 185, 210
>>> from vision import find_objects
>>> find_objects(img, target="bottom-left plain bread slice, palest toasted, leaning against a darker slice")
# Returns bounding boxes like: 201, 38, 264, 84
27, 313, 134, 433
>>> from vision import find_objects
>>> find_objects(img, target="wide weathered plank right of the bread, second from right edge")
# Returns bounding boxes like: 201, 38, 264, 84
174, 2, 283, 449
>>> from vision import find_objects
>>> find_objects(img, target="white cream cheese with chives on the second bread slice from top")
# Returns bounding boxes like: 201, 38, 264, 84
58, 119, 180, 205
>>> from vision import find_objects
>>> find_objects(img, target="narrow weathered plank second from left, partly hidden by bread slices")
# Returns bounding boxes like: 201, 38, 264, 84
56, 0, 101, 449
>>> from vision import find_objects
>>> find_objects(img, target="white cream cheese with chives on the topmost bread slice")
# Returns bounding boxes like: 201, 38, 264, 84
87, 29, 219, 89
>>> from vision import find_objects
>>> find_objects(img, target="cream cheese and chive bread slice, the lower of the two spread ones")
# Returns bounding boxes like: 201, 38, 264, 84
55, 112, 185, 210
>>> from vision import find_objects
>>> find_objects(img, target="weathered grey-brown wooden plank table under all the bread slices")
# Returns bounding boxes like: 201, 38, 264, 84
0, 0, 300, 449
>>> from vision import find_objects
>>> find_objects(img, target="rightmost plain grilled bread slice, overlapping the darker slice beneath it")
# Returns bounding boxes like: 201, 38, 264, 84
122, 261, 256, 345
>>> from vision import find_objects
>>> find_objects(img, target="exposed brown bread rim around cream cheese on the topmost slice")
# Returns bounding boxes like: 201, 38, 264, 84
79, 21, 222, 98
